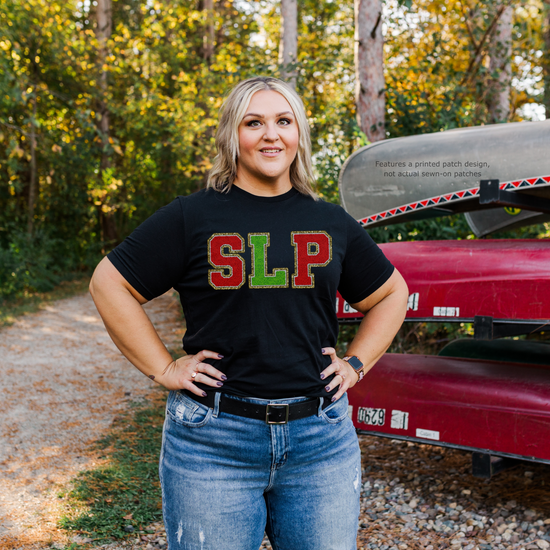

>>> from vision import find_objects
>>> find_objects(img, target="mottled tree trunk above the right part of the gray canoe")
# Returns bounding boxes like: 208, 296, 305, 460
487, 0, 514, 123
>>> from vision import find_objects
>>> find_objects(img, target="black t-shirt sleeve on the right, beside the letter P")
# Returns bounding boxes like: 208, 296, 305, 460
338, 213, 395, 304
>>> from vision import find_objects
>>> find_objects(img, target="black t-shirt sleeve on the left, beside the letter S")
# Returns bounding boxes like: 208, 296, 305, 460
107, 199, 185, 300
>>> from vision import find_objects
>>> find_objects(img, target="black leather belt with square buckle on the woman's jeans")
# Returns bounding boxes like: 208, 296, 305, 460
182, 390, 330, 424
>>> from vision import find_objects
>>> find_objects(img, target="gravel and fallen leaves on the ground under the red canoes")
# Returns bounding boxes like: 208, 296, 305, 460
358, 436, 550, 550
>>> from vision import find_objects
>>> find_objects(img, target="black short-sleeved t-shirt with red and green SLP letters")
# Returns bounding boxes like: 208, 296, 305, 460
109, 186, 393, 399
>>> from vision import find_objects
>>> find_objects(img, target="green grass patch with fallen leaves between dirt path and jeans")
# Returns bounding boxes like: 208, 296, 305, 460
60, 390, 166, 541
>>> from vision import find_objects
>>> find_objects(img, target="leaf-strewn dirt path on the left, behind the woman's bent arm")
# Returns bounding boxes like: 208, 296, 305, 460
0, 295, 182, 548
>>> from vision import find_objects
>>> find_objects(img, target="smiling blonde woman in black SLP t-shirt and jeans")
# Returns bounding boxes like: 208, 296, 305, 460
90, 78, 407, 550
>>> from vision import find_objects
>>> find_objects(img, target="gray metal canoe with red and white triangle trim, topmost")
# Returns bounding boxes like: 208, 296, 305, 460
339, 120, 550, 231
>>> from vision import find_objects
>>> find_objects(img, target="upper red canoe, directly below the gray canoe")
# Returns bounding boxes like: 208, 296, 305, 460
336, 239, 550, 324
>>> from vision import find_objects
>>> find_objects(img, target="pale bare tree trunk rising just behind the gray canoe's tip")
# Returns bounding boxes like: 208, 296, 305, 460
355, 0, 386, 142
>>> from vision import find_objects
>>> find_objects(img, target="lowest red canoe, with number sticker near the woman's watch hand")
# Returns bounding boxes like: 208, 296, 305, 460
348, 354, 550, 463
